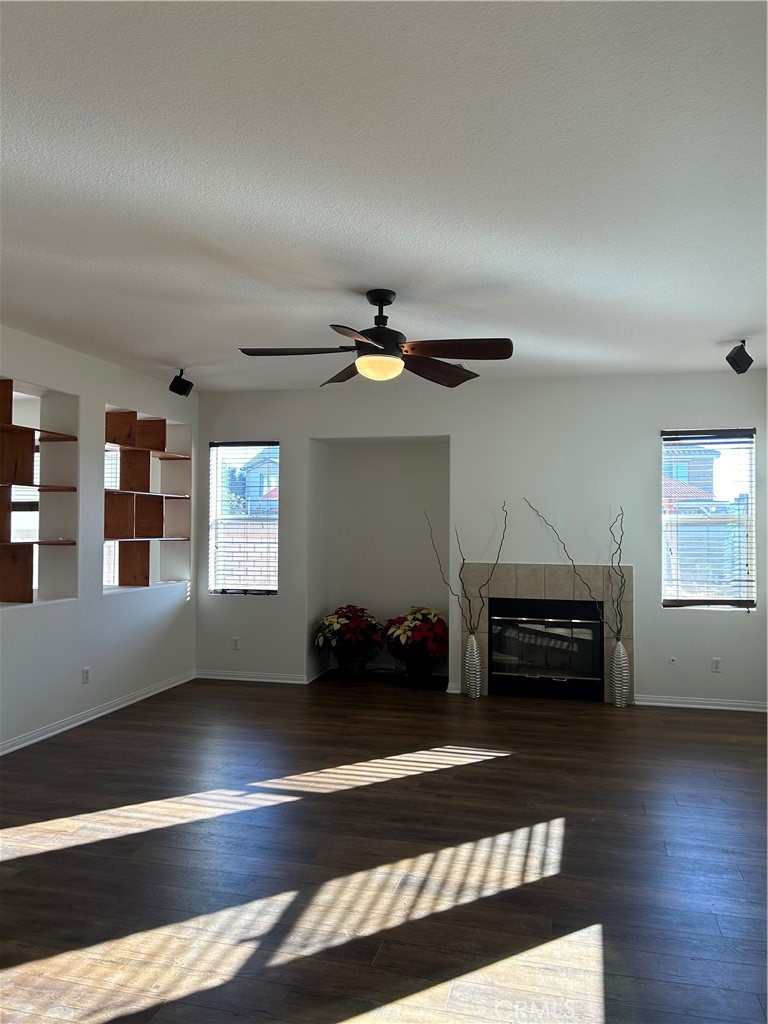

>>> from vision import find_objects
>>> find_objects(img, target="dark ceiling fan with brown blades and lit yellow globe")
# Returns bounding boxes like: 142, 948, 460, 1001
241, 288, 512, 387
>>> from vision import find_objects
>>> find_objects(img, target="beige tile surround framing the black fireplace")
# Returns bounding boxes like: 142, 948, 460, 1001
462, 562, 635, 703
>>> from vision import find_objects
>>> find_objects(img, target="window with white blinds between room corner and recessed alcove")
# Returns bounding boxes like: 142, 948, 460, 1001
208, 441, 280, 594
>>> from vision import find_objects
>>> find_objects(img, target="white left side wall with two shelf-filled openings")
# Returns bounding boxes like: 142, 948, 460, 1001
0, 329, 198, 750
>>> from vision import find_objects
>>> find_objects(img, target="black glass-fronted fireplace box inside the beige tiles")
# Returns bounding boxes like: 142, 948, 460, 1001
488, 597, 604, 700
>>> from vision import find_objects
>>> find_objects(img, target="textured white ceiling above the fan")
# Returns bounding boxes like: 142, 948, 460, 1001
2, 2, 766, 389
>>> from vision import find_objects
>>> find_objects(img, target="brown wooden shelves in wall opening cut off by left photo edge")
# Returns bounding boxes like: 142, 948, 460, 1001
0, 378, 78, 604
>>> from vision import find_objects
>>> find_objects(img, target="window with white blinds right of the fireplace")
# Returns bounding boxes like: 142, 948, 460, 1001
662, 429, 757, 608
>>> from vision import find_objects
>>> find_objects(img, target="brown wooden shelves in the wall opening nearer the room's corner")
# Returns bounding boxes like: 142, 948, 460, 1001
104, 410, 191, 587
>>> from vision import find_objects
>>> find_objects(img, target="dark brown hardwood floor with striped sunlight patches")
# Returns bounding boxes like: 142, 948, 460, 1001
0, 680, 766, 1024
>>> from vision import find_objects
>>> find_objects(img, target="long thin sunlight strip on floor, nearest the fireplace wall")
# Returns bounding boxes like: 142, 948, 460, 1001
0, 746, 518, 861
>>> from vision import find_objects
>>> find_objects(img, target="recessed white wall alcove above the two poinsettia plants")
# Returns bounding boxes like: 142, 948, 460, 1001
307, 437, 450, 660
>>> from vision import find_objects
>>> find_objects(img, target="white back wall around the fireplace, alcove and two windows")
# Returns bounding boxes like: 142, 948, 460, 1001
198, 370, 768, 708
